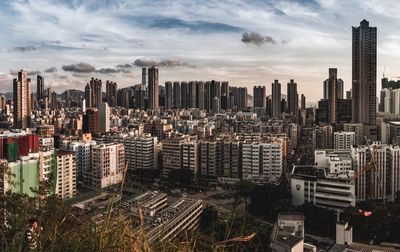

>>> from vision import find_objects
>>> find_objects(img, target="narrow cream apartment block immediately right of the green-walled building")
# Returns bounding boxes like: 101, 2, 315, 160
55, 151, 76, 199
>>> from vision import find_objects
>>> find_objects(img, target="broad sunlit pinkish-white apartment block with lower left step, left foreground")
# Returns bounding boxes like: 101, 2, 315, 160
83, 144, 125, 188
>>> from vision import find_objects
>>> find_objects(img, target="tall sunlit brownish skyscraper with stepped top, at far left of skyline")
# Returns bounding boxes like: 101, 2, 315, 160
13, 69, 32, 129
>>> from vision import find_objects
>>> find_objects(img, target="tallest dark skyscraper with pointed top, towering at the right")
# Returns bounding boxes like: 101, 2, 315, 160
352, 19, 377, 127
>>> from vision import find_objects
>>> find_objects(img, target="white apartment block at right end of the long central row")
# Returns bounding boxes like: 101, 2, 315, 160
242, 141, 283, 183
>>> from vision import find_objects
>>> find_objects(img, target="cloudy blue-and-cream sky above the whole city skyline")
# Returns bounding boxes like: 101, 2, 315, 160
0, 0, 400, 102
